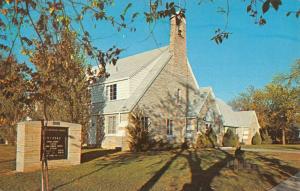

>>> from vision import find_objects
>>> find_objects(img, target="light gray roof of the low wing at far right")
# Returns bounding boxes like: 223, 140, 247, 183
216, 98, 257, 127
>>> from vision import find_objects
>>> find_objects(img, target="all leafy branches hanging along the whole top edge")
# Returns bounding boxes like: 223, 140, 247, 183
0, 0, 300, 67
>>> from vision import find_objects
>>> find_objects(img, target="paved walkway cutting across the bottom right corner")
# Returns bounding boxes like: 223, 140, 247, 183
270, 172, 300, 191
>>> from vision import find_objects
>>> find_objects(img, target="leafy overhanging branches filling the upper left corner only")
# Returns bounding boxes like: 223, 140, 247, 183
0, 0, 138, 75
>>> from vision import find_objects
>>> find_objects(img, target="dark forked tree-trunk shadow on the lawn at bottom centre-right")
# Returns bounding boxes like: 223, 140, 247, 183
183, 150, 233, 191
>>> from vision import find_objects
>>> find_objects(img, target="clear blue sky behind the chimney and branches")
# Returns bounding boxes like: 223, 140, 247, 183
13, 0, 300, 101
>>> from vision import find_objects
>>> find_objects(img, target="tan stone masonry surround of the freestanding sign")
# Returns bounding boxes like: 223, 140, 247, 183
16, 121, 81, 172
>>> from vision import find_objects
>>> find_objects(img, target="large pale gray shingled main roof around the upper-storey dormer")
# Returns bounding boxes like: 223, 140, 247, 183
93, 47, 171, 114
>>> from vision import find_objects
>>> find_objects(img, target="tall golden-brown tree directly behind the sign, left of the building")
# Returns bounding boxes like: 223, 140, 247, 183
31, 30, 91, 142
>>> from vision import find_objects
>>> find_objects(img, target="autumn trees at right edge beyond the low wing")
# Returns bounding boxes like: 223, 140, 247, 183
230, 60, 300, 144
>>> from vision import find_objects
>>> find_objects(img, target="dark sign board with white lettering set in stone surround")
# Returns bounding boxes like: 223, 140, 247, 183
41, 126, 68, 160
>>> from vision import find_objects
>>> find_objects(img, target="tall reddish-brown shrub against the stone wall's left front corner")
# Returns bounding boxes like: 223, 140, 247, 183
127, 111, 152, 152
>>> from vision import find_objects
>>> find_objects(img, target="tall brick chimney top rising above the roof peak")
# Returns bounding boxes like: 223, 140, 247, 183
170, 13, 187, 65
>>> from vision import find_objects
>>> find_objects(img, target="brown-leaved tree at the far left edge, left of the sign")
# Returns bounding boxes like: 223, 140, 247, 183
0, 57, 30, 144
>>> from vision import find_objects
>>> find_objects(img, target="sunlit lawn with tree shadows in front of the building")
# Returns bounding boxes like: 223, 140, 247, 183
0, 146, 300, 190
